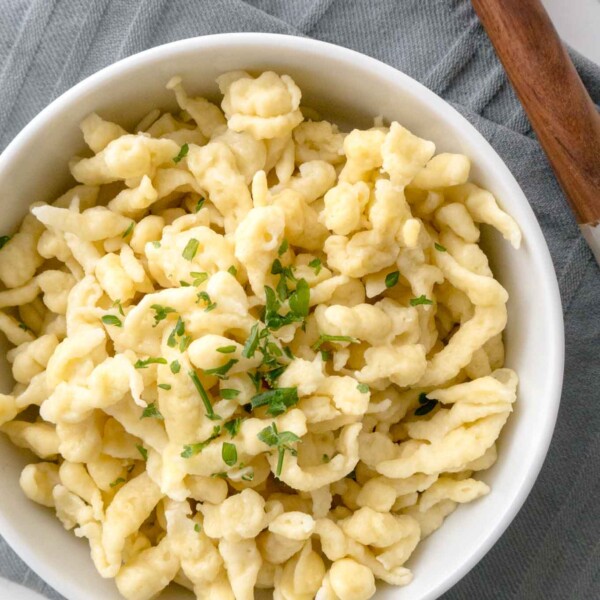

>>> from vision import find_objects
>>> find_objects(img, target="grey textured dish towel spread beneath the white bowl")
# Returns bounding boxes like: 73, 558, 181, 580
0, 0, 600, 600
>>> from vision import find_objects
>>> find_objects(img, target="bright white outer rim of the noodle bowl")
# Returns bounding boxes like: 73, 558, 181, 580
0, 32, 565, 600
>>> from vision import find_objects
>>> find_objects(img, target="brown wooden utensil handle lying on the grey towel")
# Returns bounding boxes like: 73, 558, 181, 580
471, 0, 600, 224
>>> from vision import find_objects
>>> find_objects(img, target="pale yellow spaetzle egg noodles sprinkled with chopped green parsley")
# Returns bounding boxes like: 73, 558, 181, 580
0, 71, 521, 600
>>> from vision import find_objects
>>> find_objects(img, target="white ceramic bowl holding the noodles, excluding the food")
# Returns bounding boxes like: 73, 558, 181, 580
0, 33, 564, 600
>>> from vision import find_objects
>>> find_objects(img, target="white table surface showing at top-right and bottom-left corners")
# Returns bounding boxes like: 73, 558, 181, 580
0, 0, 600, 600
